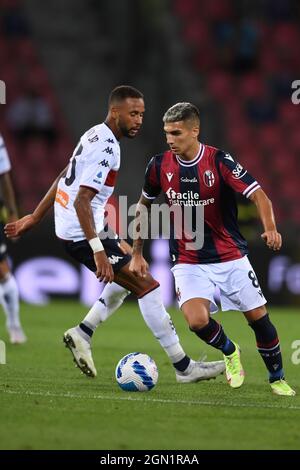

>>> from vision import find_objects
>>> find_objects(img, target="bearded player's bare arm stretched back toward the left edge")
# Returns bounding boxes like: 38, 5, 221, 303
4, 168, 67, 238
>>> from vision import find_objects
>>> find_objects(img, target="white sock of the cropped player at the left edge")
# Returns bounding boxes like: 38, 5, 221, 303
0, 274, 21, 329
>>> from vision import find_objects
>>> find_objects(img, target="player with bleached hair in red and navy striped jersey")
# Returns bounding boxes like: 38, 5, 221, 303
130, 103, 295, 396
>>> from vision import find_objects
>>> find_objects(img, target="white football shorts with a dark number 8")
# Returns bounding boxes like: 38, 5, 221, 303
171, 256, 267, 313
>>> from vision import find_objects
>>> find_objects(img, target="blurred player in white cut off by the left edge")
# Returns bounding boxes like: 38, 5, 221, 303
0, 135, 26, 344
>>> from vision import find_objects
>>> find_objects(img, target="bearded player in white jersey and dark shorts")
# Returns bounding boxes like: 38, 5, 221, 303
6, 85, 225, 383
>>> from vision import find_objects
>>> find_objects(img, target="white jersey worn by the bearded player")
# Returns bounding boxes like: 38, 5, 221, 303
54, 123, 120, 241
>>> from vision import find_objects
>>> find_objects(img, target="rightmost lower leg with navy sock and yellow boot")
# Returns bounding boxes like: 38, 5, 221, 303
245, 307, 296, 396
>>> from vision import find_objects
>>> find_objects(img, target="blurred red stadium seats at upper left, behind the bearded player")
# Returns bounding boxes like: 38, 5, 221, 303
0, 0, 73, 211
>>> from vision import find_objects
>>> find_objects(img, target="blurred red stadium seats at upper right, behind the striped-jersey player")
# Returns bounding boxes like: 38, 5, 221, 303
174, 0, 300, 225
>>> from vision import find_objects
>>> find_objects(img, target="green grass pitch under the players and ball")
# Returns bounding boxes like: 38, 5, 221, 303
0, 301, 300, 450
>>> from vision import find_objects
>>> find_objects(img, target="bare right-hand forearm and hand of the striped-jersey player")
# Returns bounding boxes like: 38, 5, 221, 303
249, 189, 282, 251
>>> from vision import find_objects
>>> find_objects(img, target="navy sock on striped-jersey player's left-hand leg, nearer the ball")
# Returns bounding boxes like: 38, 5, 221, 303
192, 317, 235, 356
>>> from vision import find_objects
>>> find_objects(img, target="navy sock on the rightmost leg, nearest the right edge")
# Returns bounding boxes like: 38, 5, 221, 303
249, 314, 284, 383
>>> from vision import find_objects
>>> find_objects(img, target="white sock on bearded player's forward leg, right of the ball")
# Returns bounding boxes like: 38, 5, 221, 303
139, 287, 186, 364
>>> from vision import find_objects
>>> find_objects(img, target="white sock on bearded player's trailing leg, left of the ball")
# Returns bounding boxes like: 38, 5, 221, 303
82, 282, 130, 331
